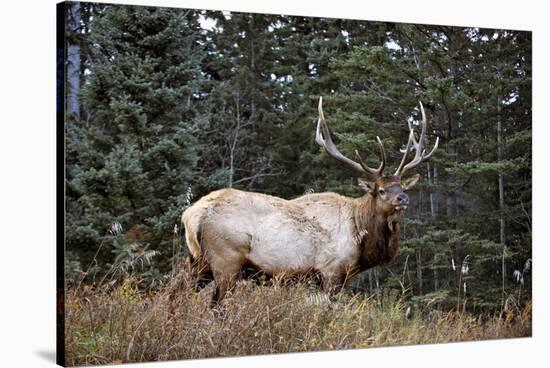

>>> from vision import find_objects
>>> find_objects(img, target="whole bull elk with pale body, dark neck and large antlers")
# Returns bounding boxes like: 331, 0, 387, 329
181, 98, 439, 305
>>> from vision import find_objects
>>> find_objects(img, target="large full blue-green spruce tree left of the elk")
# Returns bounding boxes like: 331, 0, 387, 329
66, 5, 203, 272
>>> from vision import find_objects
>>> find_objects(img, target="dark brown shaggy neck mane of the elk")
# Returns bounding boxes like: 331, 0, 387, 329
353, 193, 401, 270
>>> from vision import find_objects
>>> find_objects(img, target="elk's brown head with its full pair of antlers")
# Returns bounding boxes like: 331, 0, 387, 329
315, 97, 439, 216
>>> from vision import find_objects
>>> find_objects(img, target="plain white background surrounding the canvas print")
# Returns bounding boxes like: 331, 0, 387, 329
0, 0, 550, 368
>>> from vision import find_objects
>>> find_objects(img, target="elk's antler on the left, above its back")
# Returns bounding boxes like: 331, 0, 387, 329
315, 97, 386, 178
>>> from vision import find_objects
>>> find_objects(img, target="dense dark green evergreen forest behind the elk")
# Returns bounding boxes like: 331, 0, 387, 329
65, 3, 532, 312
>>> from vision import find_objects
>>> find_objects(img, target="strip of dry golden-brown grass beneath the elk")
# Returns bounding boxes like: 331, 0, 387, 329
66, 272, 531, 365
